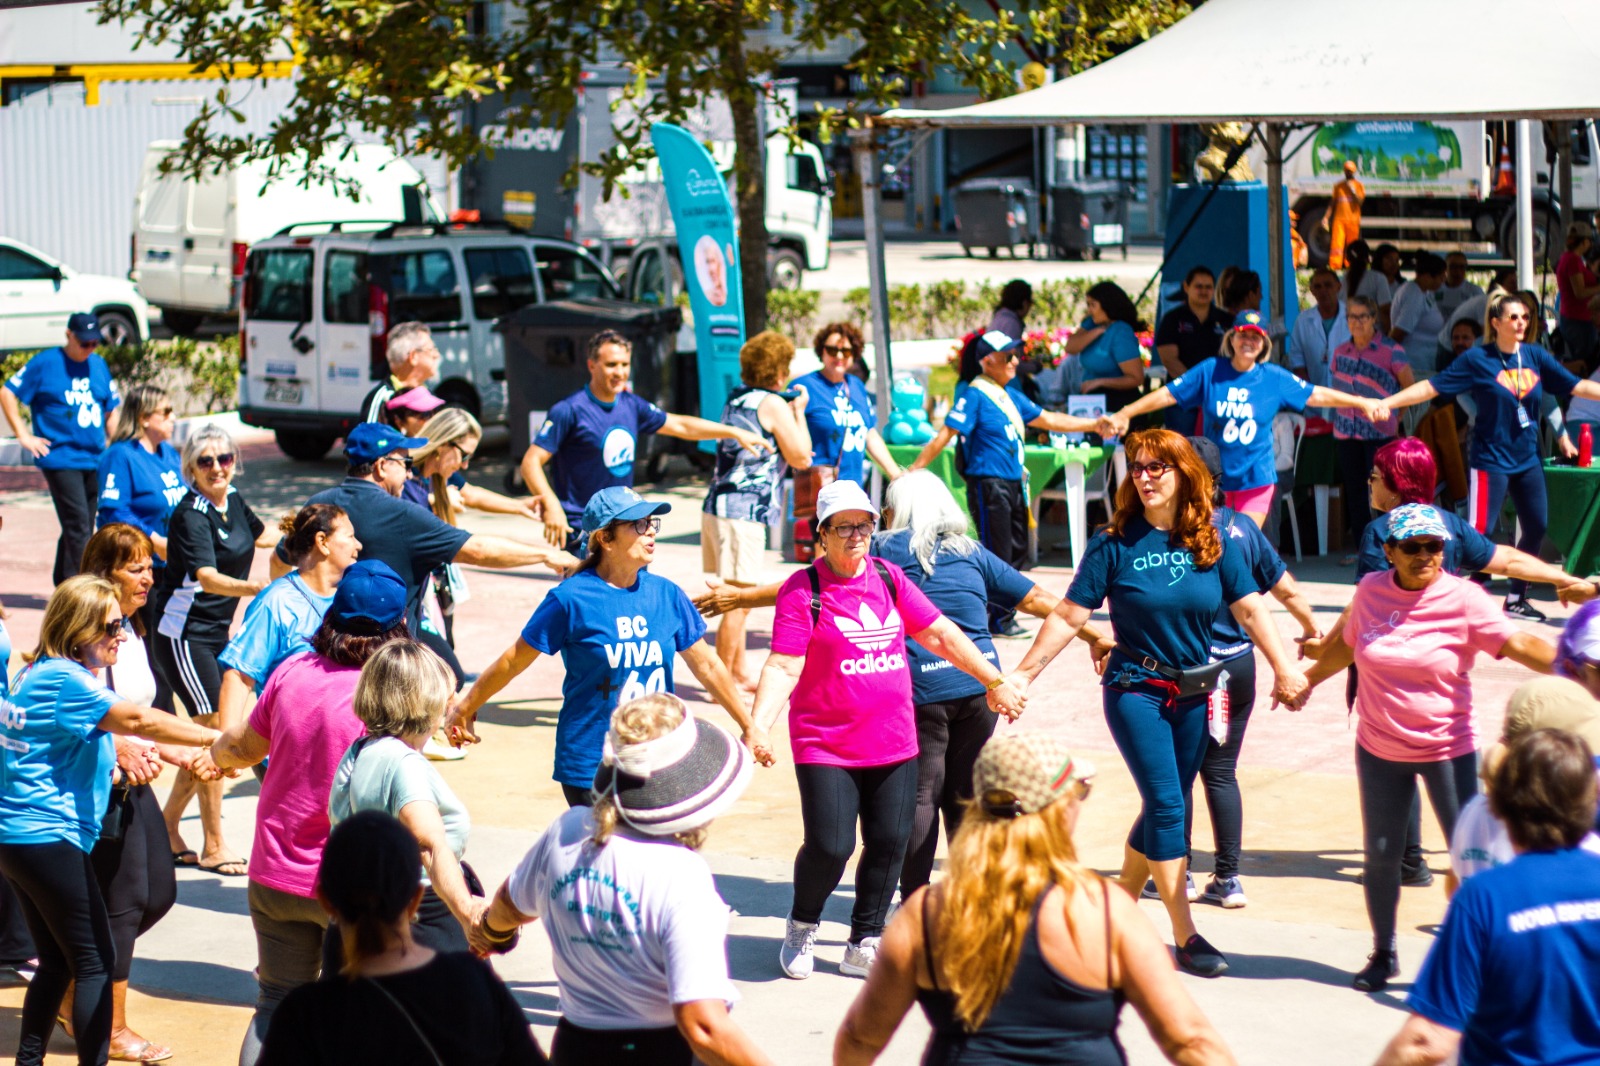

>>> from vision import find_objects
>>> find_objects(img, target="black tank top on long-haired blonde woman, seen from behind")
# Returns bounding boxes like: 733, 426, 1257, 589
917, 884, 1128, 1066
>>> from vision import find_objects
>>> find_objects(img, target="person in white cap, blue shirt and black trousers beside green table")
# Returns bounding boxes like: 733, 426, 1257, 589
910, 330, 1096, 637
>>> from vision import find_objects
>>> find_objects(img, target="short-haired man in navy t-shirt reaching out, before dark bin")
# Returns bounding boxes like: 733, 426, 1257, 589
522, 330, 771, 552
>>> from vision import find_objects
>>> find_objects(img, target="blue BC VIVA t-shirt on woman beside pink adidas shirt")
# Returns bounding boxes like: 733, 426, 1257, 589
522, 570, 706, 789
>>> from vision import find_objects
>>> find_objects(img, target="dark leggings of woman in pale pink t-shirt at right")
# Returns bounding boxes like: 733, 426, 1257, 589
1355, 744, 1478, 951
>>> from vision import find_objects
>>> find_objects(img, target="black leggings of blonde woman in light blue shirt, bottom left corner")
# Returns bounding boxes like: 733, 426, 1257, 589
0, 840, 117, 1066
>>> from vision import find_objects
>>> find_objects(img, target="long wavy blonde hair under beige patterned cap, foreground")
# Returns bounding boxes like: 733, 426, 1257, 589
923, 797, 1104, 1032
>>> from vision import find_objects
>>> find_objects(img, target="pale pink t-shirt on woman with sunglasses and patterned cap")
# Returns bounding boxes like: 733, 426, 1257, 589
1344, 570, 1518, 762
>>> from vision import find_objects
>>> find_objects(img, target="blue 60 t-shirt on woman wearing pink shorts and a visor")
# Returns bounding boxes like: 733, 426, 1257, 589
1166, 355, 1317, 491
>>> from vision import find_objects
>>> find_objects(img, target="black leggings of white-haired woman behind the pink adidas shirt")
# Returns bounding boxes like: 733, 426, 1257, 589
901, 693, 1000, 900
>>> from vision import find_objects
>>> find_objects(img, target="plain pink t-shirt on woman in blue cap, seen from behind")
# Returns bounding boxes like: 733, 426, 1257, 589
250, 651, 366, 898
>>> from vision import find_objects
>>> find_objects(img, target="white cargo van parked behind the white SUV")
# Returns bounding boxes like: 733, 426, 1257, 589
130, 141, 443, 333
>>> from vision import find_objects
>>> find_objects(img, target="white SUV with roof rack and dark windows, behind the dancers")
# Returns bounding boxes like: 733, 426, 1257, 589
238, 222, 621, 459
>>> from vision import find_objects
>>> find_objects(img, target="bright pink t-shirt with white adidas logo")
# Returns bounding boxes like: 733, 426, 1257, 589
773, 557, 942, 767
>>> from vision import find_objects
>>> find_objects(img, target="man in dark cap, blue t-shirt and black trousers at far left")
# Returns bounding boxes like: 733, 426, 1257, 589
0, 312, 122, 584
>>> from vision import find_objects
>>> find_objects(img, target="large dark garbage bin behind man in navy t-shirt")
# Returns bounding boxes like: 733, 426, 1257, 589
494, 296, 681, 461
